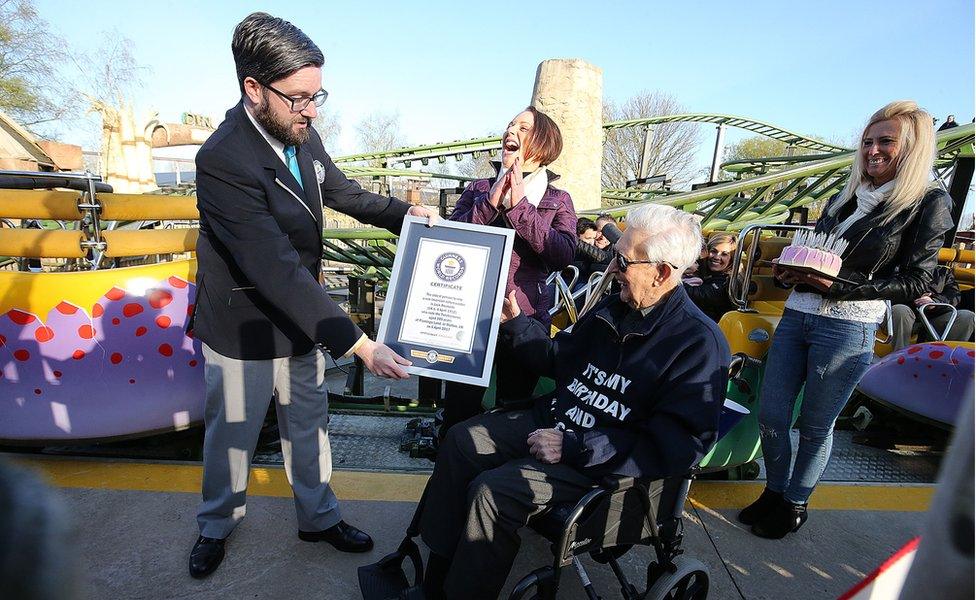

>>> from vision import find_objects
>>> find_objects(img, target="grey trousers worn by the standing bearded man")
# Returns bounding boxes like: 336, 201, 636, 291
197, 344, 340, 538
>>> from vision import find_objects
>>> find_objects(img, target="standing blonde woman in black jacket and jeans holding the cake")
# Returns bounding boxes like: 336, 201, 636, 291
738, 100, 952, 538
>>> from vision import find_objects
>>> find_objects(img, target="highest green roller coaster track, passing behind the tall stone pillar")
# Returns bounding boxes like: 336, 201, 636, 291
333, 113, 850, 167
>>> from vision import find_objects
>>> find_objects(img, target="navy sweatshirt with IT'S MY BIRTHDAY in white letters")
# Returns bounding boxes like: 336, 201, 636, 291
501, 286, 731, 479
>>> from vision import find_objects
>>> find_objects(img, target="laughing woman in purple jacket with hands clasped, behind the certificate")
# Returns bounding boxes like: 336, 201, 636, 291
441, 106, 576, 435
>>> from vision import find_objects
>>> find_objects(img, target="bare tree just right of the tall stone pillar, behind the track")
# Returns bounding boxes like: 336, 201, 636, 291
602, 91, 700, 188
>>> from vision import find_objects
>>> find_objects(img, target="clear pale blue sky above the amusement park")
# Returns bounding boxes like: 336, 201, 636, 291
37, 0, 974, 170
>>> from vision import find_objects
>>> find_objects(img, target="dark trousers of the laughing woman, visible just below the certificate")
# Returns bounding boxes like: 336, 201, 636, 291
441, 340, 539, 438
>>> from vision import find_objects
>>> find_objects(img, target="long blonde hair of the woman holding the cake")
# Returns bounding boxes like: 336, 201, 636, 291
828, 100, 935, 225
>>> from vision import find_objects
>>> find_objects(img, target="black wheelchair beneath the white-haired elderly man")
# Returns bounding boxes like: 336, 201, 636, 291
509, 469, 709, 600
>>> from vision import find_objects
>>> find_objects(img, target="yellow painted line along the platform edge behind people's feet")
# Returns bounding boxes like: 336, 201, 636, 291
12, 456, 935, 512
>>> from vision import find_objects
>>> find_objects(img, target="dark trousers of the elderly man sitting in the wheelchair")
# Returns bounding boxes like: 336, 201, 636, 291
420, 410, 594, 599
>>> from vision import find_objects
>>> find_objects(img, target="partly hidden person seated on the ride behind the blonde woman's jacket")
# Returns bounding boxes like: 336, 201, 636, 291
891, 265, 976, 350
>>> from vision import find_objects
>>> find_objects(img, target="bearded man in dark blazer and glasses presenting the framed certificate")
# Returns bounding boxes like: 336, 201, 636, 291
189, 13, 436, 577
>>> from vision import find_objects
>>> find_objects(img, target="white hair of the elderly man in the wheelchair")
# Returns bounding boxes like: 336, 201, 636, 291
627, 204, 703, 278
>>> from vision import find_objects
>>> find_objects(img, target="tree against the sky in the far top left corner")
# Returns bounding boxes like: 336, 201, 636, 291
0, 0, 76, 133
